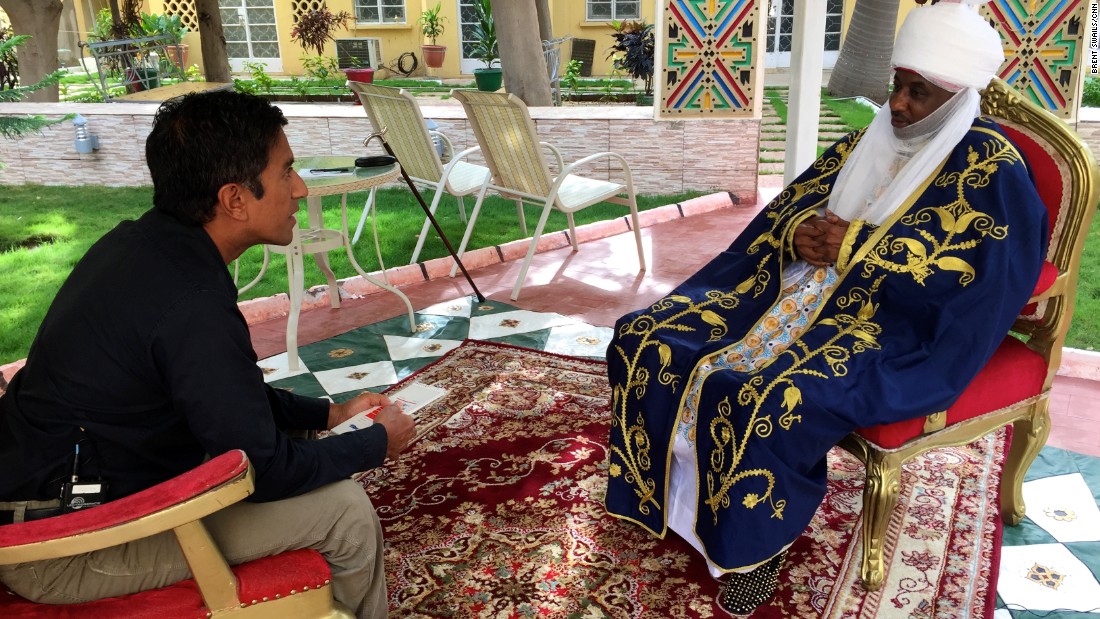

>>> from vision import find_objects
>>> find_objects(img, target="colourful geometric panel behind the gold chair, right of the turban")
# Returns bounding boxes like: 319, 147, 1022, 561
982, 0, 1089, 119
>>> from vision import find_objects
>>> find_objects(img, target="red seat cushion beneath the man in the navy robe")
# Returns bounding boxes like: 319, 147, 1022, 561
856, 335, 1046, 450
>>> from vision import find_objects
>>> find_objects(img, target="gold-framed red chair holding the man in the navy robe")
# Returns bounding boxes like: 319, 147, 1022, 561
840, 79, 1100, 590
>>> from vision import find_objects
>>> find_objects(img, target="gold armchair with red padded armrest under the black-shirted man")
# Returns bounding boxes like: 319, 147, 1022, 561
0, 451, 353, 619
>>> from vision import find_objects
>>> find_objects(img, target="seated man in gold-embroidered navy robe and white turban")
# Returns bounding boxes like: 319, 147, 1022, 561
606, 0, 1047, 612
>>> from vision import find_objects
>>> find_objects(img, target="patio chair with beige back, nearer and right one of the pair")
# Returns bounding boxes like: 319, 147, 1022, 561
451, 90, 646, 300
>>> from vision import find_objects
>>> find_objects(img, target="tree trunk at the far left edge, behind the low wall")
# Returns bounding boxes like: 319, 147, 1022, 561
0, 0, 64, 102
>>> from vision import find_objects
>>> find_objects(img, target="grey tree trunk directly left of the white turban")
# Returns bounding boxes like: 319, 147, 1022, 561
828, 0, 900, 103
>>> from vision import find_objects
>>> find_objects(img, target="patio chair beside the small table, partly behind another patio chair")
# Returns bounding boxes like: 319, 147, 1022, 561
349, 81, 490, 264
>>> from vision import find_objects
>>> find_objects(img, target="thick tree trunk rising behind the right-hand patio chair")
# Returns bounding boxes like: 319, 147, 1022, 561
493, 0, 553, 107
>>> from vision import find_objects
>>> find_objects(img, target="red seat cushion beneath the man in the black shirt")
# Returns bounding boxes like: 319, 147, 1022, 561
0, 550, 331, 619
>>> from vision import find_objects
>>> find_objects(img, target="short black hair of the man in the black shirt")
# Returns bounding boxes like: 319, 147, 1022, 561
145, 91, 286, 225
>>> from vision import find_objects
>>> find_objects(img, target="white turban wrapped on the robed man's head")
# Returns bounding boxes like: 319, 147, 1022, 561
890, 0, 1004, 91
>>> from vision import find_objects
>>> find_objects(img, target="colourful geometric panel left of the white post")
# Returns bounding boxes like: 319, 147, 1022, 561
657, 0, 760, 119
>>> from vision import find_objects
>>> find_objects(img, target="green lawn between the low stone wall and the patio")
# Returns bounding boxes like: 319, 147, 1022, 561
0, 185, 701, 365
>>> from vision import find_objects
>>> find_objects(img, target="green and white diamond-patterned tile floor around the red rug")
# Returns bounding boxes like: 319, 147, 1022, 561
259, 297, 1100, 619
